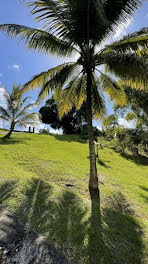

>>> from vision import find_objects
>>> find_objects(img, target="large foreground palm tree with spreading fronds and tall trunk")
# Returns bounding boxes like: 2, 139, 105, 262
0, 0, 148, 193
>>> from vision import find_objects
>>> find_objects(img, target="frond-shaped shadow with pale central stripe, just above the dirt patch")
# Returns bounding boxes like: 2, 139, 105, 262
16, 179, 53, 233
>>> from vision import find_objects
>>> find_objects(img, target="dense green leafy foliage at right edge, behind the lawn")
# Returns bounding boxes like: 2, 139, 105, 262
114, 86, 148, 153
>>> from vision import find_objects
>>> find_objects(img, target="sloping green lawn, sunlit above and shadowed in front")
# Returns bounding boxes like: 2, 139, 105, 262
0, 133, 148, 264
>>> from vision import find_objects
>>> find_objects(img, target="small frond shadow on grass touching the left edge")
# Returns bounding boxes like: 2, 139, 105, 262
0, 180, 16, 205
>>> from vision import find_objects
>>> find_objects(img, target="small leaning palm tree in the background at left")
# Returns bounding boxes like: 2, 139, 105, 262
0, 85, 37, 138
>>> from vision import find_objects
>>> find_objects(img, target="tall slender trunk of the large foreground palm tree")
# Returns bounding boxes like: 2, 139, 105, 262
87, 71, 98, 189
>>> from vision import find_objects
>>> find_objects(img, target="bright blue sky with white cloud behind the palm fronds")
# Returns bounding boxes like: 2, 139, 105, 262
0, 0, 148, 131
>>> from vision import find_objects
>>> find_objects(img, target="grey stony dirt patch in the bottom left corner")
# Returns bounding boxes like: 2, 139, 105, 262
0, 208, 72, 264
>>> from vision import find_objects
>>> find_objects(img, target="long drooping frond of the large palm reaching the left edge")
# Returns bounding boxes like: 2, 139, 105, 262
0, 24, 74, 56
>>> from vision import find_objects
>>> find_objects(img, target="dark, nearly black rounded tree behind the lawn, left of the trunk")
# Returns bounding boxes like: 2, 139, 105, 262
39, 98, 86, 134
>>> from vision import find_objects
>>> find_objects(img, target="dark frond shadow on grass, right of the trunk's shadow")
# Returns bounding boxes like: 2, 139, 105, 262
103, 193, 144, 264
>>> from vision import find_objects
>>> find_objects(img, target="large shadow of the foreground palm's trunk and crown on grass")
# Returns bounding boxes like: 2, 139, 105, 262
0, 179, 143, 264
